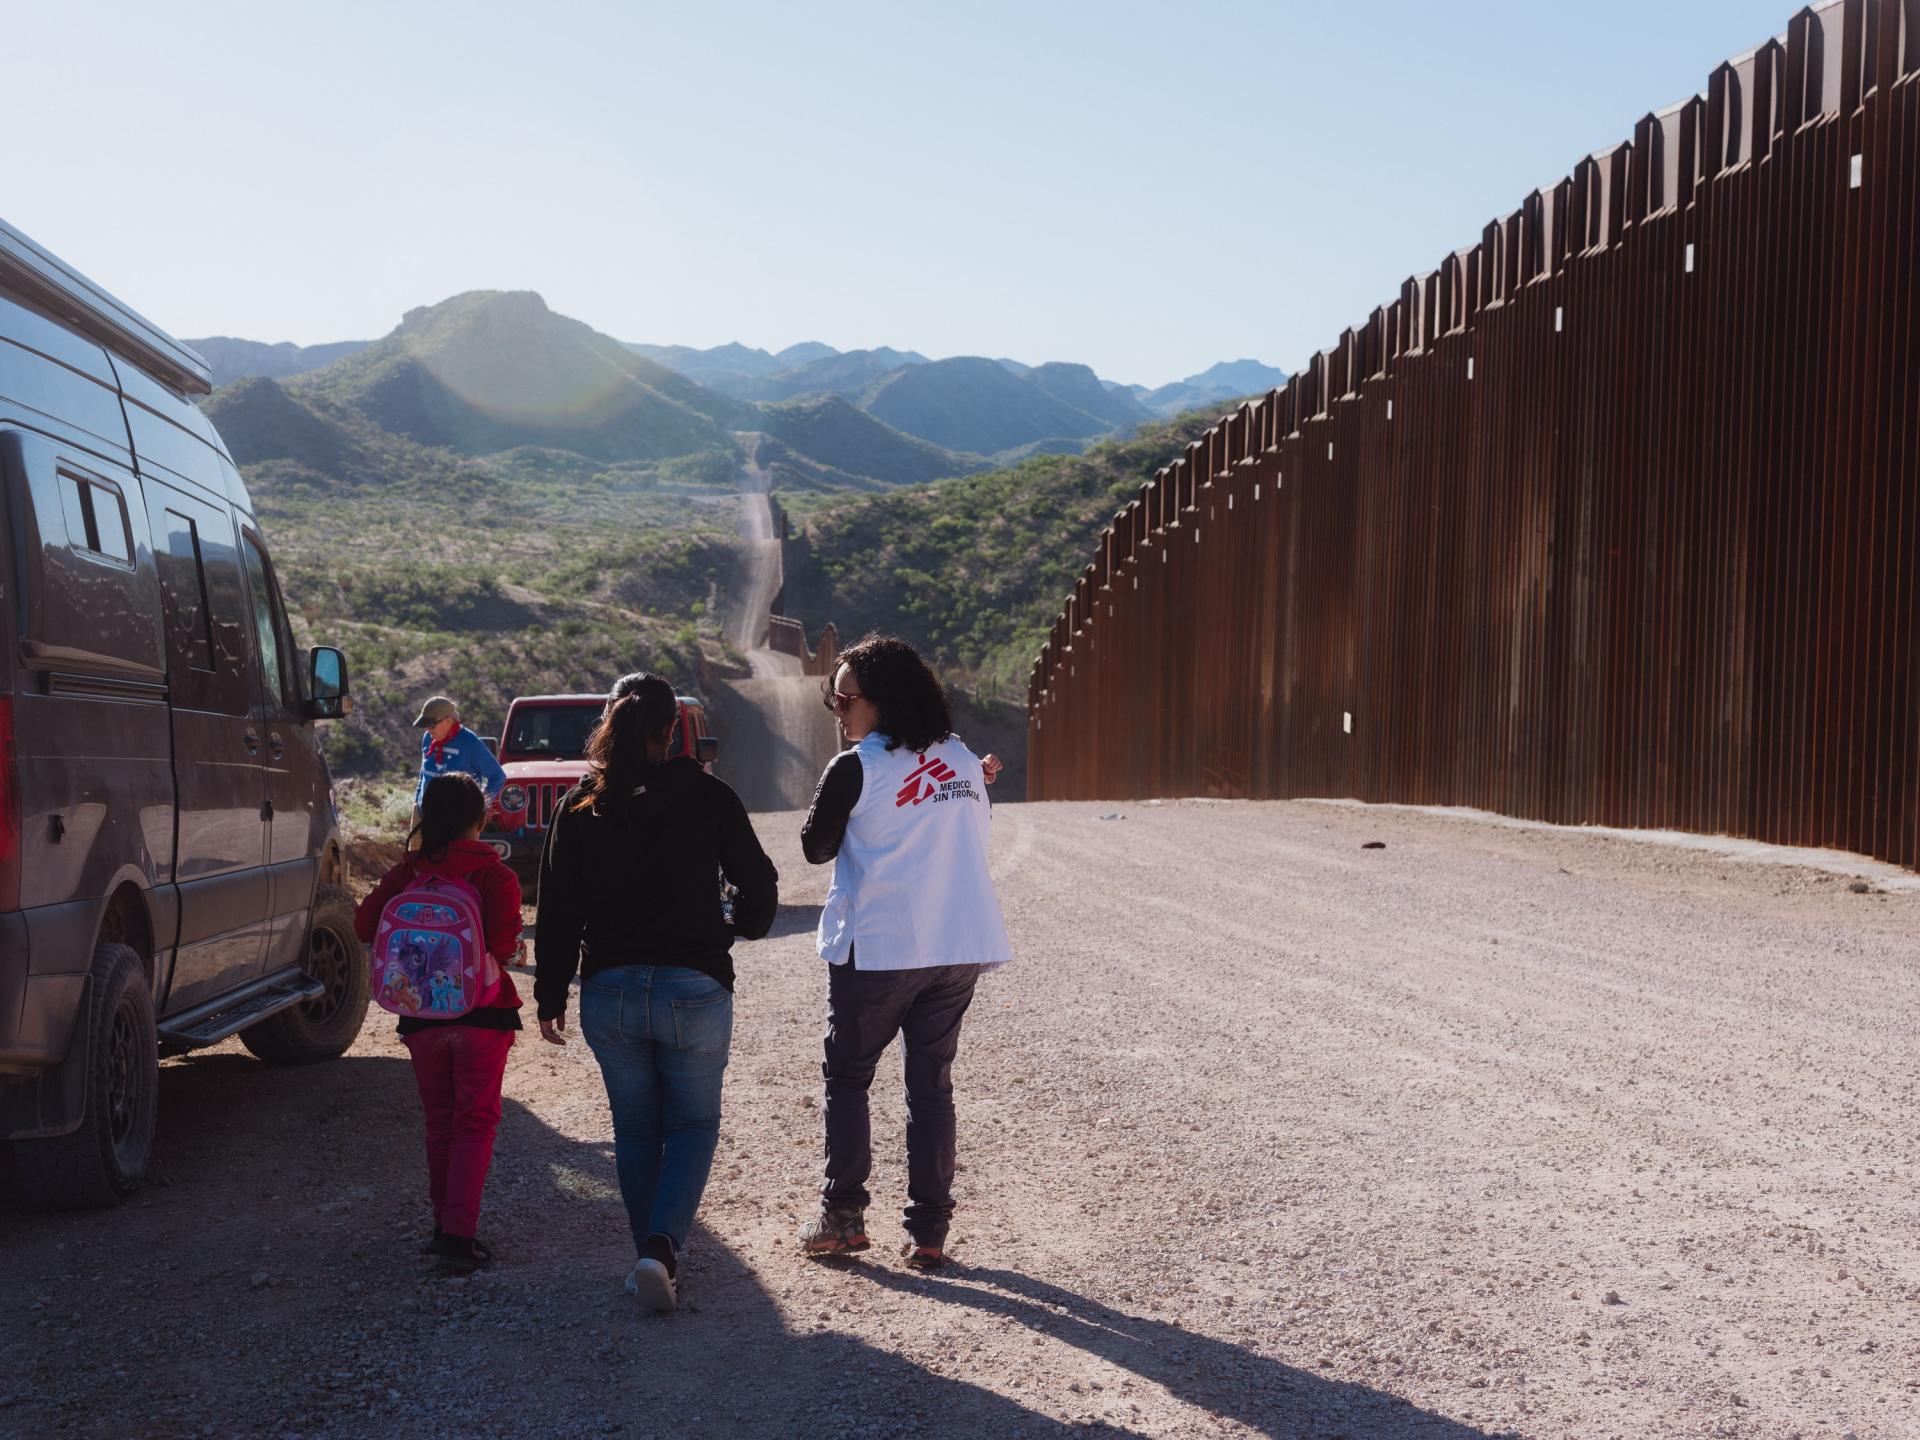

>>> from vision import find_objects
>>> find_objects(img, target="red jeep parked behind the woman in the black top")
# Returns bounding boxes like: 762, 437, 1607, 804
480, 695, 720, 904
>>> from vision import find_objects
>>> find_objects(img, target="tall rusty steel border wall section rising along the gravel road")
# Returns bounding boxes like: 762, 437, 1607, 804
1027, 0, 1920, 866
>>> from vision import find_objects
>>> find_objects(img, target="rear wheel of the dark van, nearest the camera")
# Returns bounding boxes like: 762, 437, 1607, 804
13, 943, 159, 1210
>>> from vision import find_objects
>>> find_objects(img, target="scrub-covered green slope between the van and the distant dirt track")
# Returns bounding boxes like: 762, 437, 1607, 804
246, 451, 743, 780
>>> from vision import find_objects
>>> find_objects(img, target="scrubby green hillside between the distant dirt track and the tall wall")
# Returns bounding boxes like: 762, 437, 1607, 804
787, 408, 1219, 701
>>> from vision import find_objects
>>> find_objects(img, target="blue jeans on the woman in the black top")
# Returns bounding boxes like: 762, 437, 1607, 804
580, 966, 733, 1250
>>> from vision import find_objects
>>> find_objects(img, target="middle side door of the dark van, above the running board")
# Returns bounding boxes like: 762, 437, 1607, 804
146, 478, 271, 1012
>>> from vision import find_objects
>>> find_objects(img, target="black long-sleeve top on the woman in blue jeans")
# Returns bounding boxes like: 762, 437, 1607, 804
534, 756, 780, 1020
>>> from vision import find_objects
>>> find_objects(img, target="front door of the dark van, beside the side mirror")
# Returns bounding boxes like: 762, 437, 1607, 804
240, 522, 332, 972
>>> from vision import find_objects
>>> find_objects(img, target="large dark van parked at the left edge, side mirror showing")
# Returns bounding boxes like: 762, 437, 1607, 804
0, 223, 367, 1206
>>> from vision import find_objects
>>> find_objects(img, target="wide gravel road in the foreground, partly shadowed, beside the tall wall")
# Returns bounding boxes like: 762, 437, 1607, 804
0, 803, 1920, 1440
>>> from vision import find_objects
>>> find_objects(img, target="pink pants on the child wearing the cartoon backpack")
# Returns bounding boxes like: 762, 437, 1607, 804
405, 1025, 513, 1236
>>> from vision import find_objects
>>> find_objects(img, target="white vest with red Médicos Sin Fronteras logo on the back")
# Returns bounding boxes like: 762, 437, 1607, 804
820, 735, 1014, 970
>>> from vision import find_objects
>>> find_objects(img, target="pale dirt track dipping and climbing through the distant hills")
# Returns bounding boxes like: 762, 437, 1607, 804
712, 436, 837, 812
